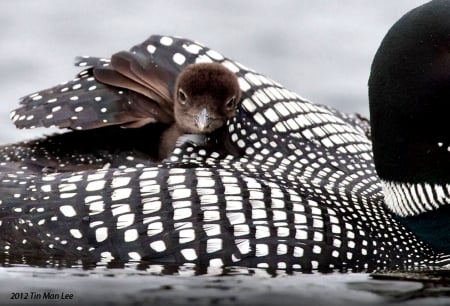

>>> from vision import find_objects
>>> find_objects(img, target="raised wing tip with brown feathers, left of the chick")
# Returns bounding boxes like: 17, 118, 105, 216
11, 36, 202, 130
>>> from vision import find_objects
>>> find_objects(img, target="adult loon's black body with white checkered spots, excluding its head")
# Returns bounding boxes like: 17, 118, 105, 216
0, 1, 449, 271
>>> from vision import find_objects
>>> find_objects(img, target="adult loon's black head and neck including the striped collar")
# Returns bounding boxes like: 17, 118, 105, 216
369, 0, 450, 253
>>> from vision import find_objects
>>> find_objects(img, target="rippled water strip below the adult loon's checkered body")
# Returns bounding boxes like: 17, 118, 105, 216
0, 266, 450, 306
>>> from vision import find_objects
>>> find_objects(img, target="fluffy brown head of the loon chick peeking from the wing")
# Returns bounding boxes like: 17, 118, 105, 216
174, 63, 241, 134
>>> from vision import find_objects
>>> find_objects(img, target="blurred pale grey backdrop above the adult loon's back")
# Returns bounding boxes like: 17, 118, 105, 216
0, 0, 426, 144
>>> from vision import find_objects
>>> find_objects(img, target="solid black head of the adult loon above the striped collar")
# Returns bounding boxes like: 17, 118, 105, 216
369, 0, 450, 184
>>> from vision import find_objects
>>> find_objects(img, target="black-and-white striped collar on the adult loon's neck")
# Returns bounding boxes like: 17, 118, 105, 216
381, 180, 450, 217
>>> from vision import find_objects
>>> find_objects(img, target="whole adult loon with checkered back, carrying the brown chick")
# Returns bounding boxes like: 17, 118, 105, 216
0, 0, 450, 272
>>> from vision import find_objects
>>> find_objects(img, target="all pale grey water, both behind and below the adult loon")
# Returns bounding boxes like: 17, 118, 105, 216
0, 0, 450, 305
